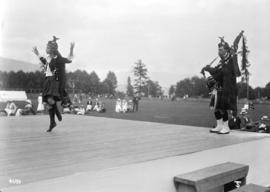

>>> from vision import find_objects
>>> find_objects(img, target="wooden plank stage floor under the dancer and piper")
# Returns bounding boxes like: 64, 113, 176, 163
0, 115, 269, 188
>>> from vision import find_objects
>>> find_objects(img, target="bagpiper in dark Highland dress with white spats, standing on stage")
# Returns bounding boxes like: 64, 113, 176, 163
203, 31, 244, 134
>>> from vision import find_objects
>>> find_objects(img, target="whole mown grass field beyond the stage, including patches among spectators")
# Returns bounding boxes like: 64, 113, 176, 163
1, 95, 270, 127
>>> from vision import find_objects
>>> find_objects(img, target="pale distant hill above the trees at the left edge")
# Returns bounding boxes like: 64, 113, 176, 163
0, 57, 40, 72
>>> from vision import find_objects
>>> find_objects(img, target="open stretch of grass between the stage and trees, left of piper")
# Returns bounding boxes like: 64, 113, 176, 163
85, 99, 216, 126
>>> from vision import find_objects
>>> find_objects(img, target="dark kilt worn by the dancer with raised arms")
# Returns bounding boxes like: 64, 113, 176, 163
42, 76, 60, 103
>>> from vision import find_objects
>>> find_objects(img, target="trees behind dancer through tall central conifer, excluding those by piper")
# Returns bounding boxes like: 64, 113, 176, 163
0, 60, 163, 97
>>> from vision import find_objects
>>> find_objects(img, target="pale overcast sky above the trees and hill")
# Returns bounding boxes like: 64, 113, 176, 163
0, 0, 270, 88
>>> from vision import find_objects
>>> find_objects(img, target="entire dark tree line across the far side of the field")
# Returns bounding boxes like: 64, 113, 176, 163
0, 60, 270, 99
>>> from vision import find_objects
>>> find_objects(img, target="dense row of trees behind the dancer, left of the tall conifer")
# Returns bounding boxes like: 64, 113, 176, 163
0, 70, 117, 95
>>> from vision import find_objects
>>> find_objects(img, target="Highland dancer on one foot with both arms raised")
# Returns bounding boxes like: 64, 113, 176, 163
33, 37, 74, 132
